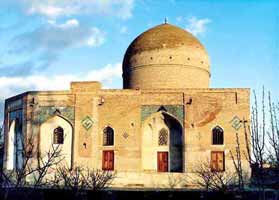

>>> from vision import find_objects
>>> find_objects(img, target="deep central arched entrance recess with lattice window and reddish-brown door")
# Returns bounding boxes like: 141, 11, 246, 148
142, 110, 183, 172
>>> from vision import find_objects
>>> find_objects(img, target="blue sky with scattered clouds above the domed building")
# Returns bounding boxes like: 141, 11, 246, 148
0, 0, 279, 121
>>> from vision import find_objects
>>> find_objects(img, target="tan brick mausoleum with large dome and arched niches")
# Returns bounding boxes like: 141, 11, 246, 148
4, 23, 250, 188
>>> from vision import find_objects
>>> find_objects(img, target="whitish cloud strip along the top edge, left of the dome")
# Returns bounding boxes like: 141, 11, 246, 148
24, 0, 134, 19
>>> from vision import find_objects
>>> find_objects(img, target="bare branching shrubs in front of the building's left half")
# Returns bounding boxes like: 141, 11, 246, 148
0, 132, 115, 199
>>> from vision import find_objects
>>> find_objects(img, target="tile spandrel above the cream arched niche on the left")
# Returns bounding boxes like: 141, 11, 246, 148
35, 106, 75, 125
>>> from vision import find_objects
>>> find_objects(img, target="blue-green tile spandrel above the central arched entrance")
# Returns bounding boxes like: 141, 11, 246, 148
141, 105, 184, 124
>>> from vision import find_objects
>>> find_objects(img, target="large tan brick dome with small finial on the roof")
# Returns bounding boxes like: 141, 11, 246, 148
122, 23, 210, 89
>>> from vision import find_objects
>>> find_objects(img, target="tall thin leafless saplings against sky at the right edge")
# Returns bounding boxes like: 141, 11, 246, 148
234, 88, 279, 199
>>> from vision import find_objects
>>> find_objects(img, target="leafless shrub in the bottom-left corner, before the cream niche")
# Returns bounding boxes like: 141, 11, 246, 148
0, 133, 64, 199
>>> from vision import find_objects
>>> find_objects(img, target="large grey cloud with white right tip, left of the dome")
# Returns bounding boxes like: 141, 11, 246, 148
4, 19, 105, 76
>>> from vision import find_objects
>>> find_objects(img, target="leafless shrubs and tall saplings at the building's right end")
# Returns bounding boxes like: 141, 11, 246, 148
195, 89, 279, 199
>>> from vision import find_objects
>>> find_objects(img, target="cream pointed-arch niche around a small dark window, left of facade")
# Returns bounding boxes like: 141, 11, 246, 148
39, 115, 73, 168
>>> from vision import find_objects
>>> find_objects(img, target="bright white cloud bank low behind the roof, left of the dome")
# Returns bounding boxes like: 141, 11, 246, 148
0, 63, 122, 121
